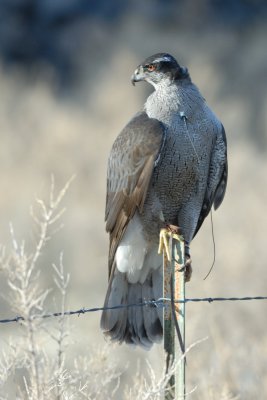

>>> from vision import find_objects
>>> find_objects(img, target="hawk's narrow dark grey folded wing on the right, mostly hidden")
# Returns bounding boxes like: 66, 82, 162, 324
194, 125, 228, 236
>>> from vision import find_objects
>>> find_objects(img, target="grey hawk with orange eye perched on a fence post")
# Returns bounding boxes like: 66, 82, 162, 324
101, 53, 227, 348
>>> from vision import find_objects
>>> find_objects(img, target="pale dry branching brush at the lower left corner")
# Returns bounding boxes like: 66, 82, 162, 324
0, 178, 121, 400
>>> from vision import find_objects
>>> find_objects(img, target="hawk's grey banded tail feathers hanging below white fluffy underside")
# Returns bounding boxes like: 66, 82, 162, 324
101, 269, 162, 348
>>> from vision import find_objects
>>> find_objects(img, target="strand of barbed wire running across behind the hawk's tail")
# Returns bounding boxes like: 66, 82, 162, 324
0, 296, 267, 324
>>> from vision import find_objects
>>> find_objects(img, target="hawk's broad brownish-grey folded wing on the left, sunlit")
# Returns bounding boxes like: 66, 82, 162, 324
105, 112, 164, 275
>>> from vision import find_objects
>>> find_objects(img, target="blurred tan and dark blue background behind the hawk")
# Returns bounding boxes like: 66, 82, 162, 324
0, 0, 267, 400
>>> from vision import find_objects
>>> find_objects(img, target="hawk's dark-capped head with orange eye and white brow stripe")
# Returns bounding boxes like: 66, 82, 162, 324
131, 53, 189, 88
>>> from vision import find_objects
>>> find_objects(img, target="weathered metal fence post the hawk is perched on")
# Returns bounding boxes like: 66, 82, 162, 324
163, 231, 185, 400
